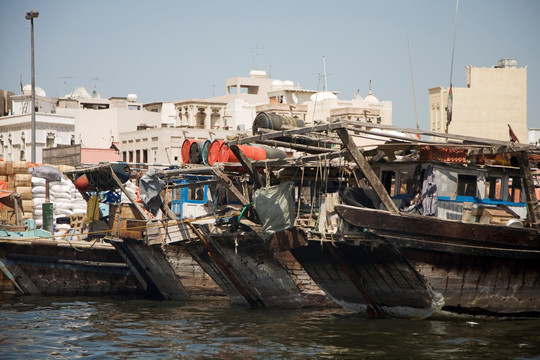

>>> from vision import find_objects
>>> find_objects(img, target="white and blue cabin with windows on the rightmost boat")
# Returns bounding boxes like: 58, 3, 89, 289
374, 161, 527, 221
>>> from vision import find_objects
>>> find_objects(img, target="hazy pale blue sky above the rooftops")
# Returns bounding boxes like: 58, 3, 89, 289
0, 0, 540, 131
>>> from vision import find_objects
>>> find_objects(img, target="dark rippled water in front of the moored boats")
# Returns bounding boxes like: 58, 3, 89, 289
0, 295, 540, 359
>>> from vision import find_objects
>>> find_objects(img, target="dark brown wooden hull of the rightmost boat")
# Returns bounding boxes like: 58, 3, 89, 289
336, 205, 540, 316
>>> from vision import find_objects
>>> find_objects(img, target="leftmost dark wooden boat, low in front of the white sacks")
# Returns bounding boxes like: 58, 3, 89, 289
0, 186, 143, 296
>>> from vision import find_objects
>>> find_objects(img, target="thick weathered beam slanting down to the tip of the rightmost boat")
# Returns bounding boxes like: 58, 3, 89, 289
336, 128, 399, 214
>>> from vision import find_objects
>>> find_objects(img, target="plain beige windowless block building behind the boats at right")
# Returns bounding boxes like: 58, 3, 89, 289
429, 59, 527, 142
